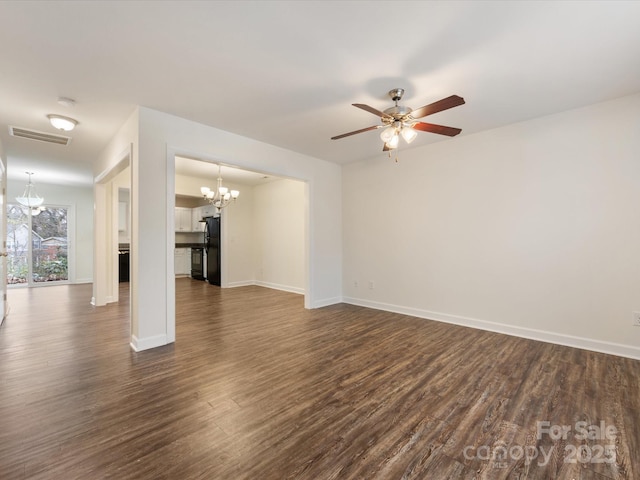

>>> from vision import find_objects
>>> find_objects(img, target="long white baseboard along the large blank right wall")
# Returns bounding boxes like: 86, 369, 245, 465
342, 297, 640, 360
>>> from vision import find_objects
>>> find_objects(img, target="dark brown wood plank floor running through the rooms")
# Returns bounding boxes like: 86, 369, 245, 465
0, 279, 640, 480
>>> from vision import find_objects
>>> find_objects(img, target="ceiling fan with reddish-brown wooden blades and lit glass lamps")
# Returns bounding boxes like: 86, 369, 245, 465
331, 88, 464, 152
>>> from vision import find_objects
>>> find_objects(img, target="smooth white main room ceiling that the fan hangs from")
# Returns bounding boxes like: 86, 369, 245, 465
0, 0, 640, 184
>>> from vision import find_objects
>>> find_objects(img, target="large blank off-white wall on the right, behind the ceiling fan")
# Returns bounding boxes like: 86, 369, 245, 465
343, 95, 640, 358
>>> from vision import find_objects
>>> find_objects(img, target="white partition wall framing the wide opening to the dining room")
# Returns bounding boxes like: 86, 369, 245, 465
94, 107, 342, 350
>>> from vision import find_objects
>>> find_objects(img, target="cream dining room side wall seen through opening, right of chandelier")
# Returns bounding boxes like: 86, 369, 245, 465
254, 179, 305, 293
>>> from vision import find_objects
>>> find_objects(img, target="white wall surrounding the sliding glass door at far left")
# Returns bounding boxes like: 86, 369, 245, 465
7, 179, 93, 283
